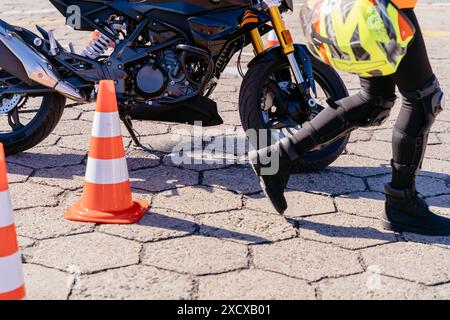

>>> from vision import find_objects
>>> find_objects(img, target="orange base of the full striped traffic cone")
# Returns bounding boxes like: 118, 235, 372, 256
64, 200, 150, 224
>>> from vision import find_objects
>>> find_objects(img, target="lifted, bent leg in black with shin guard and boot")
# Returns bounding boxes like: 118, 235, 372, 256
249, 77, 395, 212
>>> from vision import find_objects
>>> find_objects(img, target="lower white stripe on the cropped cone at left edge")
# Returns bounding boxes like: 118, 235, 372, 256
0, 252, 24, 293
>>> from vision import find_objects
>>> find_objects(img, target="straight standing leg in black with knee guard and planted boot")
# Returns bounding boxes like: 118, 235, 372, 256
383, 10, 450, 235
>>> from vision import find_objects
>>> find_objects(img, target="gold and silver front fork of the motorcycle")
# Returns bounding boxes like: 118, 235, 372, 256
250, 5, 316, 107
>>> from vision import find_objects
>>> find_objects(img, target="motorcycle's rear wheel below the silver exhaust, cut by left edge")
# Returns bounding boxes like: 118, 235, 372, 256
0, 93, 66, 155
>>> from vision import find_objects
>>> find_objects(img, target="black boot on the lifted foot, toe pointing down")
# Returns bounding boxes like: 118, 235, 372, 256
249, 141, 299, 213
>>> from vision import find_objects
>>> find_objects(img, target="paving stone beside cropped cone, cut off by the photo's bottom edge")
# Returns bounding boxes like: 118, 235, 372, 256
23, 263, 73, 300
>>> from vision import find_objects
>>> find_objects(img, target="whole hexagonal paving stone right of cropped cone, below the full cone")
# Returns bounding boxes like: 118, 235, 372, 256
30, 233, 141, 274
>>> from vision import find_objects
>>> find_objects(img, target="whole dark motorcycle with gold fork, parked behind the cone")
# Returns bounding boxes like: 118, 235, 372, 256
0, 0, 348, 171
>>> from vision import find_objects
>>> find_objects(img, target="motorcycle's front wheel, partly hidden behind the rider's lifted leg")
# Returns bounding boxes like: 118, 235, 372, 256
239, 53, 349, 172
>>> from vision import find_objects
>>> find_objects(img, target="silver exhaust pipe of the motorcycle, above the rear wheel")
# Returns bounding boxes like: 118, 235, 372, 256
0, 23, 86, 102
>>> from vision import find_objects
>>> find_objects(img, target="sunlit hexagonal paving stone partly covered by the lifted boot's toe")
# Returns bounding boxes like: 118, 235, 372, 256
245, 191, 336, 218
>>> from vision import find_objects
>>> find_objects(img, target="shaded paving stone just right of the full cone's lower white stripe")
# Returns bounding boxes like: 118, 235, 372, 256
130, 166, 198, 192
